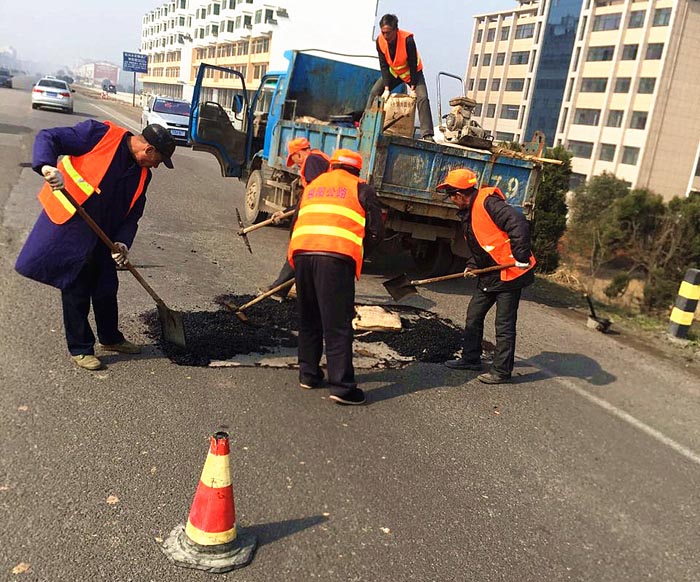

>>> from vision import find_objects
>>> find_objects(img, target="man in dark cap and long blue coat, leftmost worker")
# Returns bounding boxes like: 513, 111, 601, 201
15, 120, 175, 370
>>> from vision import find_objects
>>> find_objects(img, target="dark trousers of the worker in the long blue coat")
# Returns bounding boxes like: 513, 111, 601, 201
61, 257, 124, 356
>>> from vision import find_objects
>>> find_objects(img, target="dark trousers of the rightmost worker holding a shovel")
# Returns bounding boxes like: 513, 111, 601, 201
462, 287, 521, 377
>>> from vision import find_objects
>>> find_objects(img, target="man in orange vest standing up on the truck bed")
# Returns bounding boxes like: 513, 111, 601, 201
366, 14, 435, 141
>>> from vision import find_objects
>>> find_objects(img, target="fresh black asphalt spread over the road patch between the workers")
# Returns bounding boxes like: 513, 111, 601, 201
141, 294, 462, 366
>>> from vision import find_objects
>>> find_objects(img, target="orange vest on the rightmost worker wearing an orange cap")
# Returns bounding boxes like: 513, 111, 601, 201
471, 188, 537, 281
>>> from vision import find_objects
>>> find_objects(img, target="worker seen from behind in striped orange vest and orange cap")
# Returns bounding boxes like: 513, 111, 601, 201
288, 149, 384, 405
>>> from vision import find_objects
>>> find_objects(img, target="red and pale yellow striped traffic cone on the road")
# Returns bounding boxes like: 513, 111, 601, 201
161, 432, 257, 573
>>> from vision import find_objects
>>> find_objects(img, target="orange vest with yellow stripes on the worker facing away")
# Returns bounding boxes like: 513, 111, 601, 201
287, 169, 365, 279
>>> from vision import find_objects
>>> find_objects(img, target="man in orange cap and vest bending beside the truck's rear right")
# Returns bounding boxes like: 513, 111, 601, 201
436, 169, 536, 384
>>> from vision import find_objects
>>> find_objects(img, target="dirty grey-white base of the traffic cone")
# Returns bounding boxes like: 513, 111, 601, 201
160, 524, 257, 574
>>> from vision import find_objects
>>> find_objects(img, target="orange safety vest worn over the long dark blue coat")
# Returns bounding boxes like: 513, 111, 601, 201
39, 121, 148, 224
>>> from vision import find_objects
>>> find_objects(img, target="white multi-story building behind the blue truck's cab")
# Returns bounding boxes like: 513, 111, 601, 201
141, 0, 376, 107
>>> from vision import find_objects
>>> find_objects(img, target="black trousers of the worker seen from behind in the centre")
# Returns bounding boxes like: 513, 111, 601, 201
294, 254, 357, 396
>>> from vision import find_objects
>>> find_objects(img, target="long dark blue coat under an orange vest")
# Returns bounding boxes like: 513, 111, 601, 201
15, 119, 151, 289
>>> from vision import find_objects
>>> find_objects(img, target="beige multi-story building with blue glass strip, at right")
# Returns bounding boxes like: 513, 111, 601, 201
467, 0, 700, 199
